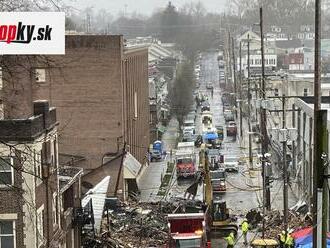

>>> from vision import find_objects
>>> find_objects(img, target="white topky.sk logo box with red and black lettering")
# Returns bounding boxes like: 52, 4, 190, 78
0, 12, 65, 55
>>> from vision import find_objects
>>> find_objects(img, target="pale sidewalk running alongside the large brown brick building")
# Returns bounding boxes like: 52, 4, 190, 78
139, 118, 179, 202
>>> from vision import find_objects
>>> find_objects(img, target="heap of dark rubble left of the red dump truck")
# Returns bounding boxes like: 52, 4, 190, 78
103, 200, 193, 248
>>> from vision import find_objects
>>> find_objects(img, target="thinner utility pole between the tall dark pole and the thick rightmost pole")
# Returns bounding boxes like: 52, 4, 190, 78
282, 94, 288, 240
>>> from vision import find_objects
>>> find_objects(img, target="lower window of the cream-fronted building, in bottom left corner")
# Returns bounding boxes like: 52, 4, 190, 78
0, 220, 15, 248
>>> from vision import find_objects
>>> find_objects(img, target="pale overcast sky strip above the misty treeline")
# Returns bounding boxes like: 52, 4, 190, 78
65, 0, 227, 15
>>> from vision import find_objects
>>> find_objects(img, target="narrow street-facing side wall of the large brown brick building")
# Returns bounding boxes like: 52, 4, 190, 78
123, 49, 150, 164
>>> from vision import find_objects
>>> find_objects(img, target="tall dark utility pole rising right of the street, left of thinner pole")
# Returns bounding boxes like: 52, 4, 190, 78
260, 5, 271, 210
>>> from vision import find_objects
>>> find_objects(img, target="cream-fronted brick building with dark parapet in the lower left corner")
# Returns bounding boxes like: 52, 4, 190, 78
0, 101, 81, 248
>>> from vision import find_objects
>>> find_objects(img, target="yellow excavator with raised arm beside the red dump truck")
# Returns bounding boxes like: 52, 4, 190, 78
199, 144, 238, 236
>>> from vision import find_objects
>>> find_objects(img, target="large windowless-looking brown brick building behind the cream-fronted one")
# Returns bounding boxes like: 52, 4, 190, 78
1, 35, 149, 199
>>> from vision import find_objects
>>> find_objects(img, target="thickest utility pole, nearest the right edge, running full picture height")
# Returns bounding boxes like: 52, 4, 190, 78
312, 0, 328, 248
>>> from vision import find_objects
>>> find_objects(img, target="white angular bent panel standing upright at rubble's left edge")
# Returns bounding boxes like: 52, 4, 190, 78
81, 176, 110, 233
